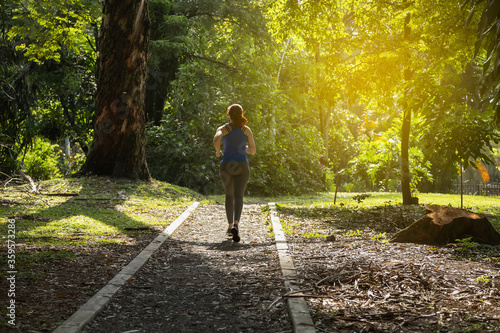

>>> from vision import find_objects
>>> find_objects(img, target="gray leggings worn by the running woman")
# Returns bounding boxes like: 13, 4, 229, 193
219, 162, 250, 224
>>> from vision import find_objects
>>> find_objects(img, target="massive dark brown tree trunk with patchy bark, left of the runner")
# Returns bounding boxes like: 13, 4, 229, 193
81, 0, 150, 179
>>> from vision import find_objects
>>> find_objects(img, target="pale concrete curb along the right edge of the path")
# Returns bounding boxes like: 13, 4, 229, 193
268, 202, 316, 333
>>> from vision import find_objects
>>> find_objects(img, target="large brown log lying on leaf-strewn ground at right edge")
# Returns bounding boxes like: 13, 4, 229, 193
390, 205, 500, 245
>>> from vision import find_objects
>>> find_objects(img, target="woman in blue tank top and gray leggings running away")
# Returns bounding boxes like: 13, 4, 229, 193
214, 104, 255, 242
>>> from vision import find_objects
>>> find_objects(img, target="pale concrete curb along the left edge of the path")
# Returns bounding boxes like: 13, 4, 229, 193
54, 202, 200, 333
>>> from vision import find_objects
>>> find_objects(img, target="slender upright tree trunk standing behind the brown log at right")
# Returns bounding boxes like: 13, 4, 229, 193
401, 2, 414, 205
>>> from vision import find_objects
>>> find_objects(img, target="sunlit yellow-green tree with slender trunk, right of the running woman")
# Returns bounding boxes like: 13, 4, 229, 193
271, 0, 484, 197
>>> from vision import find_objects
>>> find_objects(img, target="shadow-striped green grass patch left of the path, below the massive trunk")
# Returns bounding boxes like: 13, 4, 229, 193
0, 177, 202, 247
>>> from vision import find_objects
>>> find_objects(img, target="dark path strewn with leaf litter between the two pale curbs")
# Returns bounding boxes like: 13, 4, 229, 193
83, 204, 292, 333
